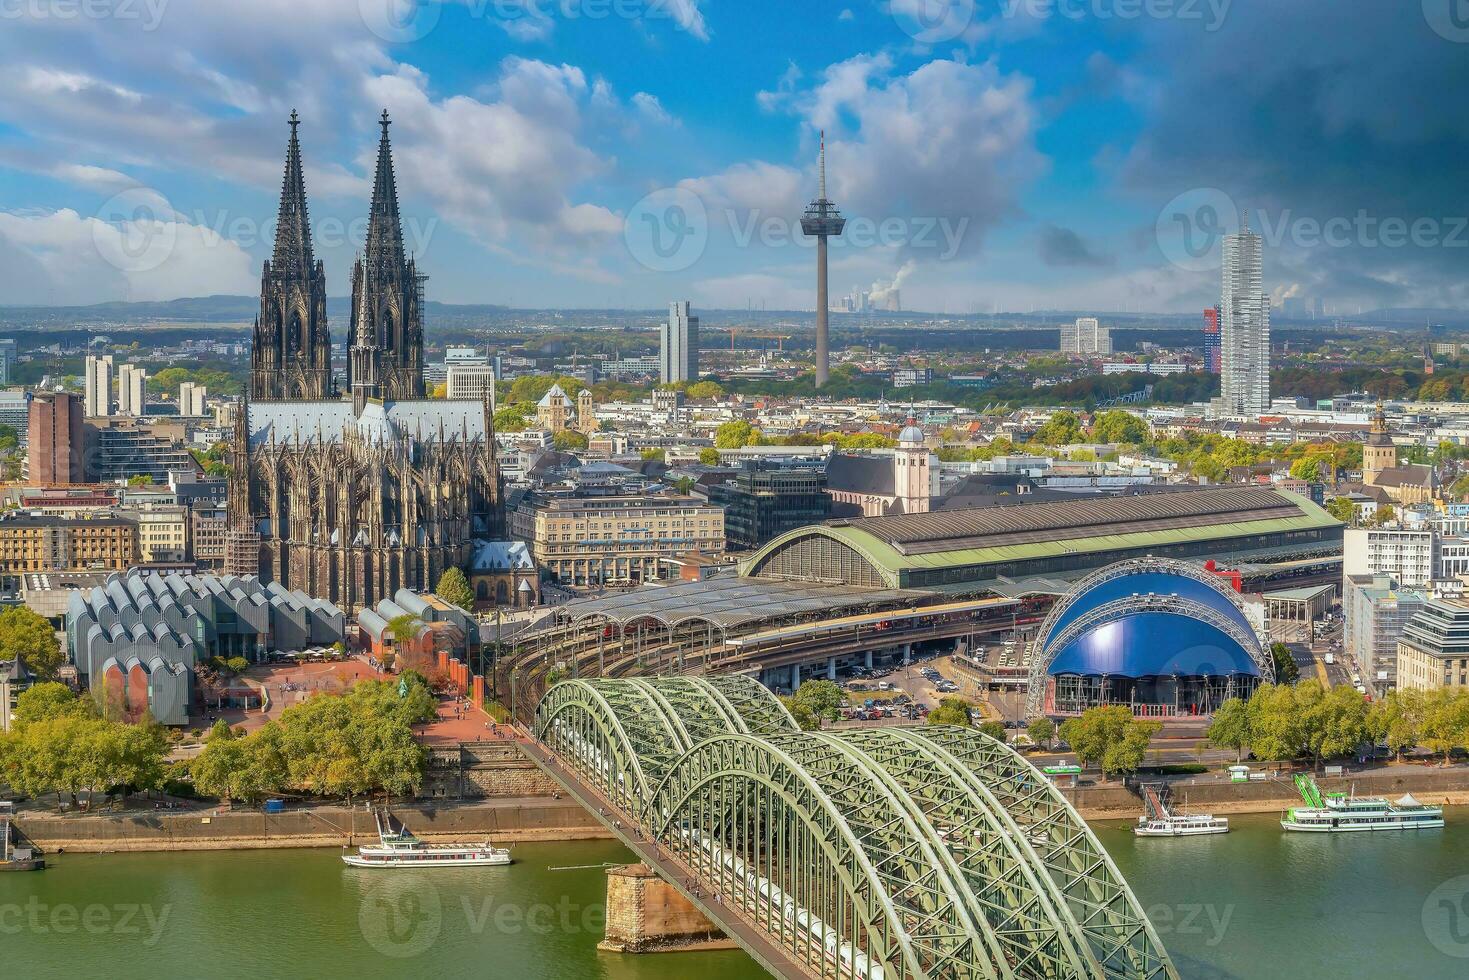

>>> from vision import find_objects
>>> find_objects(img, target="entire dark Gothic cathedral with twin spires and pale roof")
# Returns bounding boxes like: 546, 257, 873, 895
228, 112, 505, 613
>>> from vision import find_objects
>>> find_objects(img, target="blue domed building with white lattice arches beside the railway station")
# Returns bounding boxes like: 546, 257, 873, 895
1027, 558, 1275, 717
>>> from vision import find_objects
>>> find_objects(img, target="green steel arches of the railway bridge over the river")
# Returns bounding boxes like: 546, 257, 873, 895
535, 676, 1178, 980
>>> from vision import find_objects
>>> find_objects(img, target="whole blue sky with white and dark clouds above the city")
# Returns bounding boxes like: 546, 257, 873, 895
0, 0, 1469, 313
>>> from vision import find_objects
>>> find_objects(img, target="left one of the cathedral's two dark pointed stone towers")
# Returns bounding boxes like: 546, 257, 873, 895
250, 110, 333, 400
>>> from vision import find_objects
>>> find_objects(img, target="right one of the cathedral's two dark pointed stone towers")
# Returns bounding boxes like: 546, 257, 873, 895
347, 109, 425, 411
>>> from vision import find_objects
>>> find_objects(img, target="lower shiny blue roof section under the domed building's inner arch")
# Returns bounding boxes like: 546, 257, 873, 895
1046, 611, 1260, 677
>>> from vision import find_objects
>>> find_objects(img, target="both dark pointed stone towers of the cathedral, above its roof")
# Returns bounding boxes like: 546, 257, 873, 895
250, 110, 423, 408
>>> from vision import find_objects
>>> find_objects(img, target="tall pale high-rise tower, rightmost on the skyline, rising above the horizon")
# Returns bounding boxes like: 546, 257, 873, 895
1219, 216, 1271, 419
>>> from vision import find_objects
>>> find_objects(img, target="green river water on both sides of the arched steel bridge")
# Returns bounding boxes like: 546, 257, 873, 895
0, 808, 1469, 980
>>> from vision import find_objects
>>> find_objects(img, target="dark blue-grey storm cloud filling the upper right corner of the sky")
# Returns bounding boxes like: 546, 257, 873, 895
1122, 0, 1469, 307
